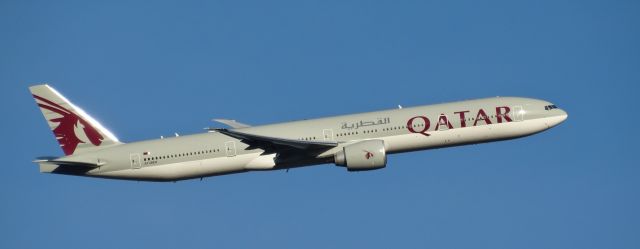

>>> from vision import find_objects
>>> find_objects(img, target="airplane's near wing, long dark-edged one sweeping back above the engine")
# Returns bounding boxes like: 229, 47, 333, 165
210, 129, 338, 150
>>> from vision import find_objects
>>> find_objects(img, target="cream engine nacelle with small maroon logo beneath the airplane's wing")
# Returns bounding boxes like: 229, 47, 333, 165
334, 140, 387, 171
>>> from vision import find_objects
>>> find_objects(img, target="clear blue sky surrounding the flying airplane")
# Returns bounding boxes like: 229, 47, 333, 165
0, 0, 640, 249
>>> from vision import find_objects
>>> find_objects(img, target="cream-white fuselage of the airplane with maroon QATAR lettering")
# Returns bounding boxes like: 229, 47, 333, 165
41, 97, 567, 181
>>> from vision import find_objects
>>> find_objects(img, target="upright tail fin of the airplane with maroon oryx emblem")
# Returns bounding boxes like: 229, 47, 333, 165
29, 84, 120, 155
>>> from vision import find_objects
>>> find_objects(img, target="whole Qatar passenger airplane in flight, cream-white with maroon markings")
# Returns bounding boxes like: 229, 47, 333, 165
29, 84, 568, 182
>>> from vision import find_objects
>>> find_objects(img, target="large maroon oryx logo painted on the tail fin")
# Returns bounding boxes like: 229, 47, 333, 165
33, 95, 104, 155
